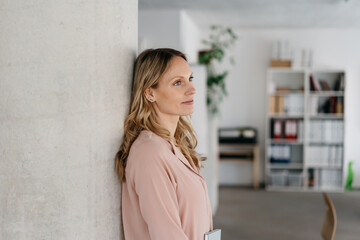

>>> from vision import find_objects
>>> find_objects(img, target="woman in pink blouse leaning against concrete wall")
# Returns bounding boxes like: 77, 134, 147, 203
116, 48, 213, 240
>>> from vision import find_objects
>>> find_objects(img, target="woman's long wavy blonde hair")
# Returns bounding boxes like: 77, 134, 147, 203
115, 48, 206, 182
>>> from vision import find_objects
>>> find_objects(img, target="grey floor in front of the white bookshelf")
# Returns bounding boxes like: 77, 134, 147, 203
214, 187, 360, 240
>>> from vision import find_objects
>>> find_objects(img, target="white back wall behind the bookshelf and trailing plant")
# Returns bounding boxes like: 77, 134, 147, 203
211, 29, 360, 187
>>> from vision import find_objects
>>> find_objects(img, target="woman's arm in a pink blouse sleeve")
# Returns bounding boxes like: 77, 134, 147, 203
130, 149, 188, 240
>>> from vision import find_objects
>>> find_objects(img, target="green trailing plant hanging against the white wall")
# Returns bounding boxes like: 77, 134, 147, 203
199, 25, 238, 114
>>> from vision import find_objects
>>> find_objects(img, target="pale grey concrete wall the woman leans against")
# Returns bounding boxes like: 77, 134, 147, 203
0, 0, 138, 240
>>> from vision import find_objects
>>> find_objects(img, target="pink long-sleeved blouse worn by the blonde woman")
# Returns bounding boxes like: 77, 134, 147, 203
122, 130, 213, 240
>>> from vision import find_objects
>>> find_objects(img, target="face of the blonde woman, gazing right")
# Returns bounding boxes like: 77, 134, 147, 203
147, 56, 196, 116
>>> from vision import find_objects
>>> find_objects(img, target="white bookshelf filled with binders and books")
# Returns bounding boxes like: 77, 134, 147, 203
265, 68, 346, 192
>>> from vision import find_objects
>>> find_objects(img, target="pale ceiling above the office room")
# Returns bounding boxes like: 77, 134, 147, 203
139, 0, 360, 29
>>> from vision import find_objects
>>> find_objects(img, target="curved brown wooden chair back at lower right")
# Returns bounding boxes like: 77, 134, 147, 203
321, 192, 337, 240
